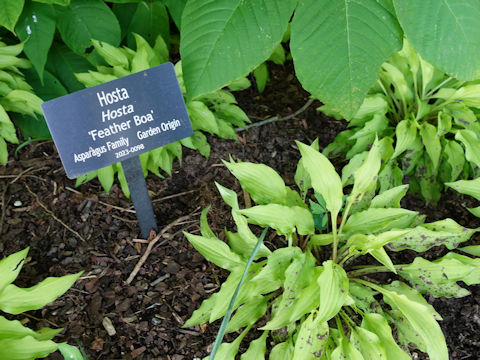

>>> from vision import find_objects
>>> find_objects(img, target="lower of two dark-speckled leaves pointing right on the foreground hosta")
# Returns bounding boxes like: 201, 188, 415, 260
397, 257, 480, 298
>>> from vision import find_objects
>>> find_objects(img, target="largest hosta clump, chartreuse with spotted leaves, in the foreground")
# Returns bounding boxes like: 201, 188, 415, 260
185, 140, 480, 360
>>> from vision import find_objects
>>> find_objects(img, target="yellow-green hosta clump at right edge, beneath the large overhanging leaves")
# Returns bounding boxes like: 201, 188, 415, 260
320, 42, 480, 202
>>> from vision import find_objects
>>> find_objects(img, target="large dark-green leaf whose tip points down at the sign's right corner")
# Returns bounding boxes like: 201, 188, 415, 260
180, 0, 297, 99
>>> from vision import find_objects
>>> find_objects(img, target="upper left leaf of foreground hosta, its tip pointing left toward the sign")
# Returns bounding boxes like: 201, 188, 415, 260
224, 161, 287, 205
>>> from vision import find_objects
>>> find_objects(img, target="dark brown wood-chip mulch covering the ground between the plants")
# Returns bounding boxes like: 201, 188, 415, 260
0, 63, 480, 360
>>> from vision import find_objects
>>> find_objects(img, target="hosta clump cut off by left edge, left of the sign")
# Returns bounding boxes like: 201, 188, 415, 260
0, 41, 42, 165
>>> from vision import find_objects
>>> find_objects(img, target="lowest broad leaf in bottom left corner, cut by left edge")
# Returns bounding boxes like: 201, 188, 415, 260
0, 336, 58, 360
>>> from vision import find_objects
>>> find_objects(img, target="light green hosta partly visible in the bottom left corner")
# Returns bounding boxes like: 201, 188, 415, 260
0, 248, 81, 360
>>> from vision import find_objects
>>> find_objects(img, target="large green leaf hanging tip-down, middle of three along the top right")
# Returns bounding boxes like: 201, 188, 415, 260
290, 0, 402, 119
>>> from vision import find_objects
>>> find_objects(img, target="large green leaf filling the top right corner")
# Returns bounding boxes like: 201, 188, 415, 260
394, 0, 480, 80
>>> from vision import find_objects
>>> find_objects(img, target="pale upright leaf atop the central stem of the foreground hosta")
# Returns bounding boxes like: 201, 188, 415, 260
296, 141, 343, 218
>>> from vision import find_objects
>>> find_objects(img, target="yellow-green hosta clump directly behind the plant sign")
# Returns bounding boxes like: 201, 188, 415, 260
76, 34, 250, 195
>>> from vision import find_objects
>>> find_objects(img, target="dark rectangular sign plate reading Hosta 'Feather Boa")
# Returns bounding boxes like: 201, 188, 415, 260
42, 63, 193, 179
